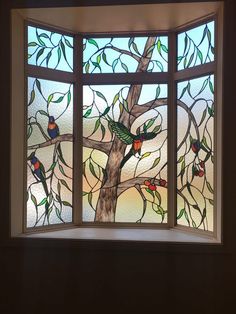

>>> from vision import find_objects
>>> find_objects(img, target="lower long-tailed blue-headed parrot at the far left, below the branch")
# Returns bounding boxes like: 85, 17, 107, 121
28, 153, 49, 218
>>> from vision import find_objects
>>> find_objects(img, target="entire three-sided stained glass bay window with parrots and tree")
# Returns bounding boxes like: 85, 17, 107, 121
25, 15, 216, 232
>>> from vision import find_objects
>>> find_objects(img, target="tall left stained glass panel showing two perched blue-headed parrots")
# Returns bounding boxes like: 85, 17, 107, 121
27, 77, 73, 227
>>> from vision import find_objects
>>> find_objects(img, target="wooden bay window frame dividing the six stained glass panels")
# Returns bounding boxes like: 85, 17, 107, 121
24, 14, 218, 236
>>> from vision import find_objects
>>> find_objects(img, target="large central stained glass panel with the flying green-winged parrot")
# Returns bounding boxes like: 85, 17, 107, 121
83, 85, 167, 223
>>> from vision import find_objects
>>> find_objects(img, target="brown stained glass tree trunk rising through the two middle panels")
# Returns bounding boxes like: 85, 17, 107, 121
95, 37, 156, 222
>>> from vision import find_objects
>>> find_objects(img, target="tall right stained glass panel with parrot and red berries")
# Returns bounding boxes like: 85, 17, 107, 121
177, 75, 214, 231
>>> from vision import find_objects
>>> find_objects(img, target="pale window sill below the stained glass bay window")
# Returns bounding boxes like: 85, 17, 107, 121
17, 227, 221, 244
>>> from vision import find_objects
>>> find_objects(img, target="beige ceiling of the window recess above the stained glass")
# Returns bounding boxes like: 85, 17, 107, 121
17, 1, 223, 33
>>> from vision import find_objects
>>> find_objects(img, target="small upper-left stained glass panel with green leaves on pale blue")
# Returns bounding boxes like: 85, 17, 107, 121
28, 26, 73, 72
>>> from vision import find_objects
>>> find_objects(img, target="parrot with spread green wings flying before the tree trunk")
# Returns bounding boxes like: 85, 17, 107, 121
109, 120, 158, 169
